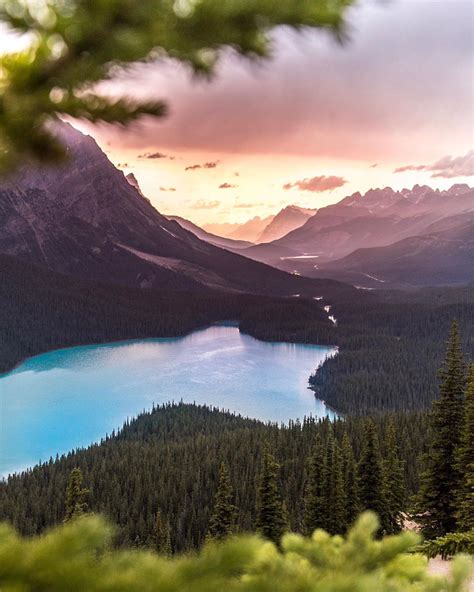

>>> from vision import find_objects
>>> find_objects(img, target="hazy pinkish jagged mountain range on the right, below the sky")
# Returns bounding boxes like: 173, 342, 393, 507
243, 184, 474, 284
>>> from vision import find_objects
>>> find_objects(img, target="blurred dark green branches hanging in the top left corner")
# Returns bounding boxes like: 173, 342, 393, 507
0, 0, 354, 169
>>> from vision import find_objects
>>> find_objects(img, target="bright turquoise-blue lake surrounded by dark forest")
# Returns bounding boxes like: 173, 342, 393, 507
0, 326, 334, 475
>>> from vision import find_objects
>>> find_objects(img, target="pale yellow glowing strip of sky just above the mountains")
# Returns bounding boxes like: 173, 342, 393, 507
73, 122, 473, 225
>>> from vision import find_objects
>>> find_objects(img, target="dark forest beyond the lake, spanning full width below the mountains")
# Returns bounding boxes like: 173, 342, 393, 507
0, 256, 474, 413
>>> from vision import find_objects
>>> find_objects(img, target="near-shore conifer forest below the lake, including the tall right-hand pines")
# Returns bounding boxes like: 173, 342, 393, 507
0, 322, 474, 555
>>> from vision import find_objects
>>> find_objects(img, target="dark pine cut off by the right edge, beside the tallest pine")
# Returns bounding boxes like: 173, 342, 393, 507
456, 364, 474, 531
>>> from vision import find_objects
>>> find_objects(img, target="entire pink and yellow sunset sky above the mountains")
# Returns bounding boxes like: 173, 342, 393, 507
3, 0, 474, 224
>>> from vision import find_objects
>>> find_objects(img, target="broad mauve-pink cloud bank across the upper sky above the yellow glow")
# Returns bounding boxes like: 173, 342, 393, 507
102, 0, 473, 162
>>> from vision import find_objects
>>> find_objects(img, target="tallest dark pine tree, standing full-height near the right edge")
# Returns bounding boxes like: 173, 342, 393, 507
416, 321, 466, 538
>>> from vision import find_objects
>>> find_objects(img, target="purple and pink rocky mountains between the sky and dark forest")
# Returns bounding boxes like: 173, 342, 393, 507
0, 124, 474, 296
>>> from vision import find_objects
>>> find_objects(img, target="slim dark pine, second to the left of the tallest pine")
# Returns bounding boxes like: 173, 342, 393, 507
357, 419, 386, 530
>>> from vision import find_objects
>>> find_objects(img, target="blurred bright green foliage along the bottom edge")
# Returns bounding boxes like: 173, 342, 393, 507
0, 513, 469, 592
